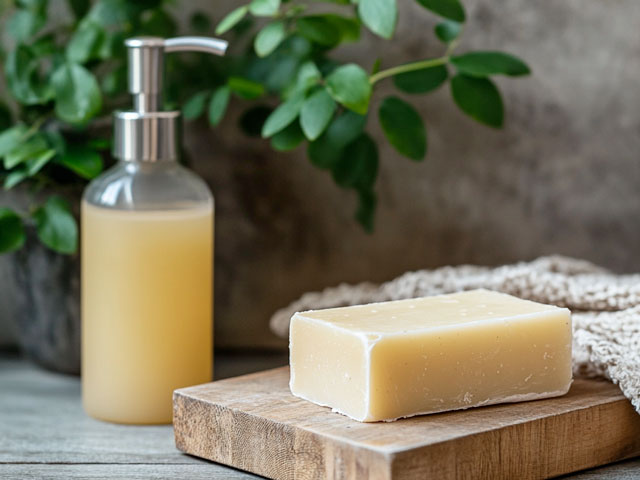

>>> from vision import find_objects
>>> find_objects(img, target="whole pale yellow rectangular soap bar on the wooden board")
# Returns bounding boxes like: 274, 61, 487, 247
289, 290, 572, 422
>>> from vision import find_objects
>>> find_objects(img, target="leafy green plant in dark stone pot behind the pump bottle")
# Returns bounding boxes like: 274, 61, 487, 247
0, 0, 529, 372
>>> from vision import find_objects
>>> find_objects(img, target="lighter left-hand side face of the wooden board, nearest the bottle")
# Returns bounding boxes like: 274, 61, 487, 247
173, 391, 393, 480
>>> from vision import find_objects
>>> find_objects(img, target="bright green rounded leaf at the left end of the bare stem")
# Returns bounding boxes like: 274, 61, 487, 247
327, 63, 371, 115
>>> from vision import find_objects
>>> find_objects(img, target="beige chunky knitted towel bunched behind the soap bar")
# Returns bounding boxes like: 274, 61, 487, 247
271, 256, 640, 413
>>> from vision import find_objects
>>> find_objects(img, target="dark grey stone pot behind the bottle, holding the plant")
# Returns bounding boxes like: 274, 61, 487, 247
0, 188, 80, 374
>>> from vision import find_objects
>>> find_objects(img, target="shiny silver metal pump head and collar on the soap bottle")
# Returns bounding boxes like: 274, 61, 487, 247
113, 37, 227, 162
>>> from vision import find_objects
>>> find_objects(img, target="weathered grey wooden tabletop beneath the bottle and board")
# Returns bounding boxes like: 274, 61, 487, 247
0, 348, 640, 480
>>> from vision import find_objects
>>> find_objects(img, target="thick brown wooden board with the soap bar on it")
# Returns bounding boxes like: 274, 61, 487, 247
174, 367, 640, 480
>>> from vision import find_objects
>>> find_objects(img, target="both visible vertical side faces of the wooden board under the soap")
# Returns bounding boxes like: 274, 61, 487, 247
174, 376, 640, 480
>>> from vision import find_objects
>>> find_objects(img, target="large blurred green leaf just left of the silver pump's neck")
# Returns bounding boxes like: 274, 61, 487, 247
51, 63, 102, 124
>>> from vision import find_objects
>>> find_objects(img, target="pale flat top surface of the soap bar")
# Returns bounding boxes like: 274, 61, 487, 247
296, 289, 565, 334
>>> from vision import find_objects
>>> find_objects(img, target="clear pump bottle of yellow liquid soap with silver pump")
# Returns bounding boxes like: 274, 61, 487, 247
81, 37, 227, 424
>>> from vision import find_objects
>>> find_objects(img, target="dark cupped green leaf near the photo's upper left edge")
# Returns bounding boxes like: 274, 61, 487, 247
5, 45, 53, 105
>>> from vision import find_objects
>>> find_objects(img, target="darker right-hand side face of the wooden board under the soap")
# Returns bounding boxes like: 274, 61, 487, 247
392, 399, 640, 480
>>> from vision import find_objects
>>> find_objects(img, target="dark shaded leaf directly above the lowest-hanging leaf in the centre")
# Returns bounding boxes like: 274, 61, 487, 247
332, 133, 378, 190
